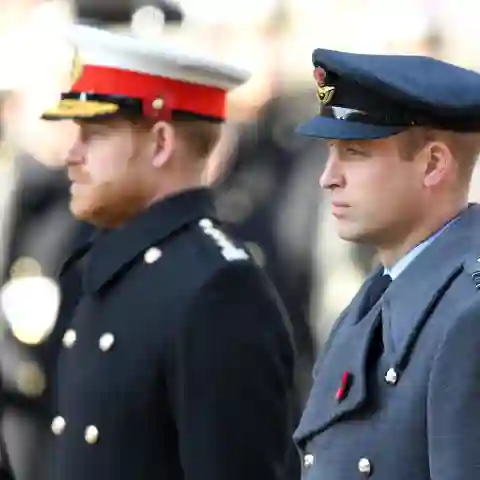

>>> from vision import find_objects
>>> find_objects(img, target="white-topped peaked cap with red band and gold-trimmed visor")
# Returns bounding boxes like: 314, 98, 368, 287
44, 25, 250, 120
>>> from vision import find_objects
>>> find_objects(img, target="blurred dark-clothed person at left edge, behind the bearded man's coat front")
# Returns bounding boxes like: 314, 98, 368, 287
0, 147, 91, 480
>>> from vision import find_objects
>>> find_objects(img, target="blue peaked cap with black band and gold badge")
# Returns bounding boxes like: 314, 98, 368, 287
297, 49, 480, 140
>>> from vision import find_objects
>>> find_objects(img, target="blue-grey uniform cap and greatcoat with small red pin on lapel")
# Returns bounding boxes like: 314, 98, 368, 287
294, 50, 480, 480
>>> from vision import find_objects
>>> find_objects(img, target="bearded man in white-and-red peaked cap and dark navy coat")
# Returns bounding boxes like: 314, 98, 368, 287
44, 27, 293, 480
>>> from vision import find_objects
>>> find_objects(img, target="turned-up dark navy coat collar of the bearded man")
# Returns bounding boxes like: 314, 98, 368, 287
78, 188, 216, 293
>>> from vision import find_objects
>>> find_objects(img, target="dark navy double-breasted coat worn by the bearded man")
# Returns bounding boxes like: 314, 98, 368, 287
48, 189, 293, 480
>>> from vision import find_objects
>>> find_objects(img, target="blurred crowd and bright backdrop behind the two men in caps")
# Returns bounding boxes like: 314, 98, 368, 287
0, 0, 480, 480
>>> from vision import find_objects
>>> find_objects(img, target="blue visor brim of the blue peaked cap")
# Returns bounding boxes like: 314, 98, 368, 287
295, 116, 407, 140
